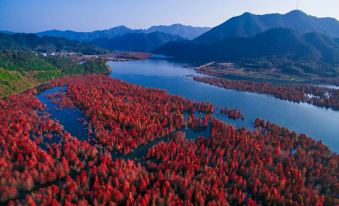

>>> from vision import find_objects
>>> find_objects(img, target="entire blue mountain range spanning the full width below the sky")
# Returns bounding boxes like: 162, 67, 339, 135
0, 10, 339, 76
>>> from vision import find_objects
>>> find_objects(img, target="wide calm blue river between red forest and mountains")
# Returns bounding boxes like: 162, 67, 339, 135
108, 59, 339, 152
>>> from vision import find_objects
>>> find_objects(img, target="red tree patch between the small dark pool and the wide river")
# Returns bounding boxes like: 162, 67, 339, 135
48, 75, 213, 154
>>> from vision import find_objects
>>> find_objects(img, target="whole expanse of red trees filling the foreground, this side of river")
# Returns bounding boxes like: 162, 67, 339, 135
0, 75, 339, 205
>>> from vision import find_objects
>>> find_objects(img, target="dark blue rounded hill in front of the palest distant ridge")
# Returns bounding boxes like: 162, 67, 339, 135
91, 32, 184, 51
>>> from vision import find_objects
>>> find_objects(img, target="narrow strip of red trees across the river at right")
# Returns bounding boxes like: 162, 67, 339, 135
193, 76, 339, 110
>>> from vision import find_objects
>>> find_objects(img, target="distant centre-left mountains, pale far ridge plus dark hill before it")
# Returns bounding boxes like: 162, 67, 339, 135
37, 24, 210, 51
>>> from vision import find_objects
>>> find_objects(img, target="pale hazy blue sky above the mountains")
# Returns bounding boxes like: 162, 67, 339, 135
0, 0, 339, 32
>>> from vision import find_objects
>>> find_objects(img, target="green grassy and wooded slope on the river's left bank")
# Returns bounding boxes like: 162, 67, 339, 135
0, 51, 110, 97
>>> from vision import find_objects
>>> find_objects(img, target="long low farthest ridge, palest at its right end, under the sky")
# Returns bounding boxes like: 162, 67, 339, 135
37, 24, 210, 41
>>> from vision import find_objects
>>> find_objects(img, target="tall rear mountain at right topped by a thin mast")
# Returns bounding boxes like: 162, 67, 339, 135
195, 10, 339, 43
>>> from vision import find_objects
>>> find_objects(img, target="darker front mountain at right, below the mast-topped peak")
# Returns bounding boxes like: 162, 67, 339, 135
155, 28, 339, 75
